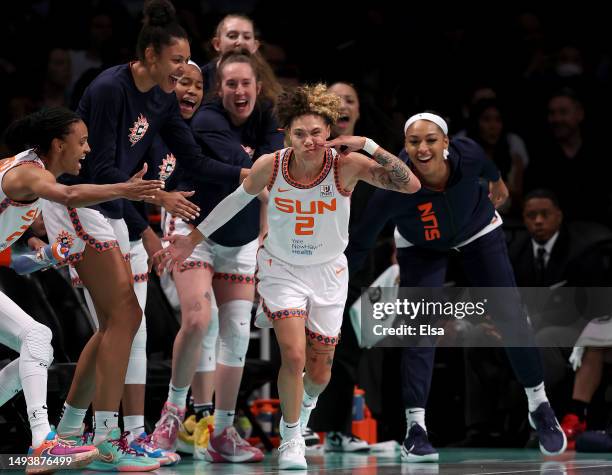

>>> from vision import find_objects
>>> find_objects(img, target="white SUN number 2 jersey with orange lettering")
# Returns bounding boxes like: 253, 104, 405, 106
264, 148, 351, 265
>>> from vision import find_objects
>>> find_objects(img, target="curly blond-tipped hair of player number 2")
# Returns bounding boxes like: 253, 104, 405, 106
277, 83, 341, 130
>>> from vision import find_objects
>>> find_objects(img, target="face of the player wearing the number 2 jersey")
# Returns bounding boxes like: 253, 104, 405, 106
289, 114, 331, 160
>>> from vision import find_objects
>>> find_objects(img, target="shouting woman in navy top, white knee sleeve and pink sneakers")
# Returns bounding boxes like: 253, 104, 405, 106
154, 51, 283, 462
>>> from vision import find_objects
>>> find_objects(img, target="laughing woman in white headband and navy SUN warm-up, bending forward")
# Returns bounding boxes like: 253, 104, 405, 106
347, 113, 566, 462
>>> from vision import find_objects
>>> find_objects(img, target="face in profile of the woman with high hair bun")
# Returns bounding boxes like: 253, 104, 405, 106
145, 38, 191, 94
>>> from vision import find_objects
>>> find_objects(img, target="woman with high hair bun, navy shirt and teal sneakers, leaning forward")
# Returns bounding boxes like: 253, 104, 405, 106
44, 0, 241, 470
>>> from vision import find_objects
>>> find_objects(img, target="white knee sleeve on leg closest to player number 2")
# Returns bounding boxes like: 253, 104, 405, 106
217, 300, 253, 367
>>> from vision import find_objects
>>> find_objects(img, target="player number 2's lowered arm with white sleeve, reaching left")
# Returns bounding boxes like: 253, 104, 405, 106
154, 154, 274, 272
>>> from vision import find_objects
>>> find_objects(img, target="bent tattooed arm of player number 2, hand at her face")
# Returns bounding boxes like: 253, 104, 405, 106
325, 136, 421, 193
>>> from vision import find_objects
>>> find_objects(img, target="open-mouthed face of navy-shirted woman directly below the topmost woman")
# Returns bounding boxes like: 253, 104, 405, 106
218, 62, 260, 125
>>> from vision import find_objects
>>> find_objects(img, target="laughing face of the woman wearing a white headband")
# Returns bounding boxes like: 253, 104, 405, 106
405, 120, 448, 178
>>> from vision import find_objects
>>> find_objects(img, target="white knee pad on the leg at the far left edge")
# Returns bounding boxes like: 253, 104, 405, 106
19, 322, 53, 378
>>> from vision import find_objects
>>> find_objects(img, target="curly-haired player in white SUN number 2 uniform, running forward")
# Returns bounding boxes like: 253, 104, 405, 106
157, 84, 420, 469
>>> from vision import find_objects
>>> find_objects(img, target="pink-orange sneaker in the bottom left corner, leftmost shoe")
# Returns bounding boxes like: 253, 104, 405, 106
26, 432, 98, 474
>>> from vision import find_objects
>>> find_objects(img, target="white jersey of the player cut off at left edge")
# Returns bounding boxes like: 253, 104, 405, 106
0, 150, 45, 251
